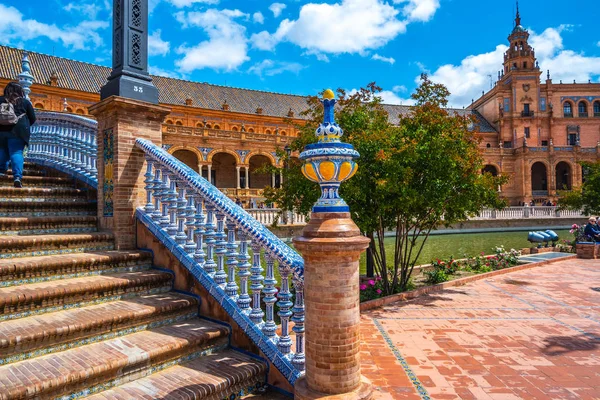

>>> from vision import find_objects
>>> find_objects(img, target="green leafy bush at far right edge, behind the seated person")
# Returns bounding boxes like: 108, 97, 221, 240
559, 162, 600, 215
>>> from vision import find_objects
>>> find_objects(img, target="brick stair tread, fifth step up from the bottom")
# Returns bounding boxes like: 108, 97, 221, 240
0, 250, 152, 281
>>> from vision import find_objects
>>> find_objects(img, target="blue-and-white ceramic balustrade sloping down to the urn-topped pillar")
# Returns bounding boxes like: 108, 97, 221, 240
136, 139, 304, 384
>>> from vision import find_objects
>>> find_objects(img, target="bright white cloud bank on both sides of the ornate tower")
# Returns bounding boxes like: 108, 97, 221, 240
431, 25, 600, 106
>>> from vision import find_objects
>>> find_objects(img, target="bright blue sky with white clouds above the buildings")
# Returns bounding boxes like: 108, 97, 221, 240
0, 0, 600, 107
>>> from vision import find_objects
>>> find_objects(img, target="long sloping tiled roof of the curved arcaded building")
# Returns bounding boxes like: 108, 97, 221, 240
0, 46, 496, 132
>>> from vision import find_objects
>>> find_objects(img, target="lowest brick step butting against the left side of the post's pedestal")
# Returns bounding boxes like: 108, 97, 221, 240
0, 216, 98, 236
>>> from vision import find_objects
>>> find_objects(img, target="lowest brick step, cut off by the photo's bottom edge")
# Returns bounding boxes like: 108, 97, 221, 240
87, 350, 267, 400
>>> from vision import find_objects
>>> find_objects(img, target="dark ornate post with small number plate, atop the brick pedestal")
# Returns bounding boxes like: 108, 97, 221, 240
100, 0, 158, 104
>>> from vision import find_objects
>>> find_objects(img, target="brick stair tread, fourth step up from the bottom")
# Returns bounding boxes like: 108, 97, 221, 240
0, 270, 172, 306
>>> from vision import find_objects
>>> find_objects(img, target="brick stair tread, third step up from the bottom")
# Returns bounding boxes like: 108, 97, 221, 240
0, 292, 197, 356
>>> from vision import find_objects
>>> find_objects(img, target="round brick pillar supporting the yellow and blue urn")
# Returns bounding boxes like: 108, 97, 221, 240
294, 213, 372, 400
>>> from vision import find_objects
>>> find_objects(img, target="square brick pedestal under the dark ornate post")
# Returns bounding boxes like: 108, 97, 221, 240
89, 96, 170, 250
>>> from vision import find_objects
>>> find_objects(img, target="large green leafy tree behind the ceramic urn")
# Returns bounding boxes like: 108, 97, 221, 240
265, 75, 506, 294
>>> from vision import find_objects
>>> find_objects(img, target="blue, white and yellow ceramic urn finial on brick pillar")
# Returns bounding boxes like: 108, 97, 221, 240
300, 89, 360, 213
